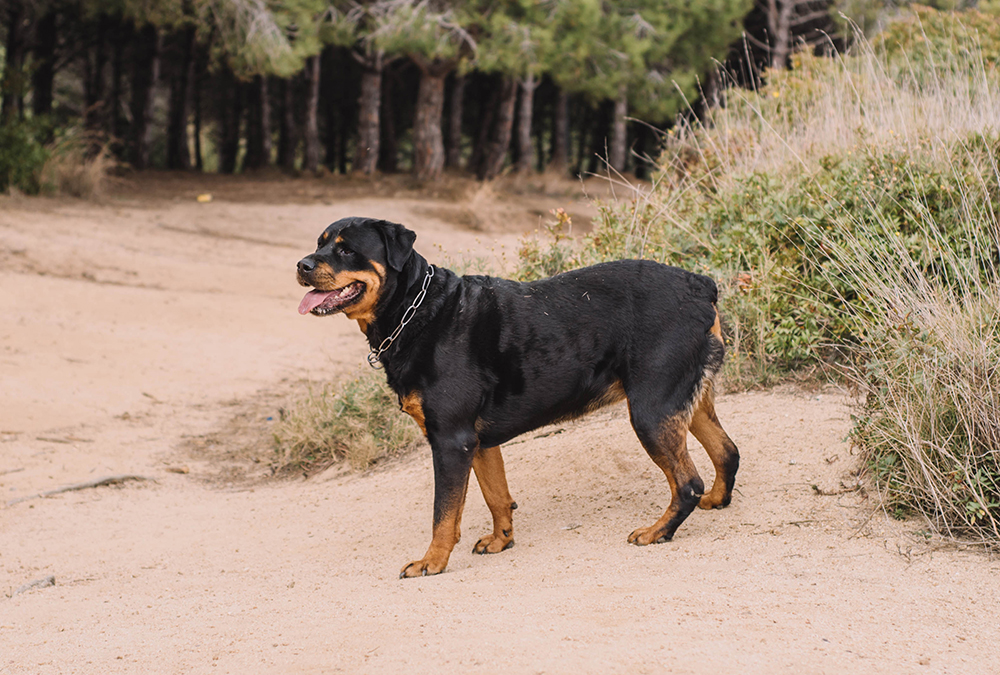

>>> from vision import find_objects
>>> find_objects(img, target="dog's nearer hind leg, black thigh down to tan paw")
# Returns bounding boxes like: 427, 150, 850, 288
628, 406, 705, 546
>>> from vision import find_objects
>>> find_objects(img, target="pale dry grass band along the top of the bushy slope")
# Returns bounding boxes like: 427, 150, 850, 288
661, 19, 1000, 193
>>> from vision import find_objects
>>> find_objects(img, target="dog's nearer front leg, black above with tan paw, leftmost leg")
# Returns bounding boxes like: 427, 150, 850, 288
399, 433, 477, 579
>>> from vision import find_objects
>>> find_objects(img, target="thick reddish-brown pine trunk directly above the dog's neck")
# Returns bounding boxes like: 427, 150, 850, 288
413, 59, 454, 180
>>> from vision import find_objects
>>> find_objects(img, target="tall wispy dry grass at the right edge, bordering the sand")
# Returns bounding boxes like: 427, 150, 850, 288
833, 174, 1000, 545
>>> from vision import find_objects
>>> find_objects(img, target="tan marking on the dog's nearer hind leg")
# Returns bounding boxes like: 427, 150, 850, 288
628, 415, 701, 546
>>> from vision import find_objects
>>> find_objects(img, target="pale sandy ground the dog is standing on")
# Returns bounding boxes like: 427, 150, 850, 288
0, 177, 1000, 674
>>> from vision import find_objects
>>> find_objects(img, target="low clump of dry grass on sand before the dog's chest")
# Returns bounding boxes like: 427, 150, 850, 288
274, 371, 420, 469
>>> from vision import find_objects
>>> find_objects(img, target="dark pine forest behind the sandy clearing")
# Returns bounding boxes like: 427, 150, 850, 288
0, 0, 856, 187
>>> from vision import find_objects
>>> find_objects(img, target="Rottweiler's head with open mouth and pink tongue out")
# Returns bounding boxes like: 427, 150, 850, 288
298, 218, 417, 322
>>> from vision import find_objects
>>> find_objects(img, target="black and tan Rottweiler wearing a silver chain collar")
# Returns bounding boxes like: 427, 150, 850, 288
298, 218, 739, 577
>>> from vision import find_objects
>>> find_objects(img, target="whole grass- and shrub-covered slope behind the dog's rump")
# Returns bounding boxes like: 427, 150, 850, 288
522, 9, 1000, 545
